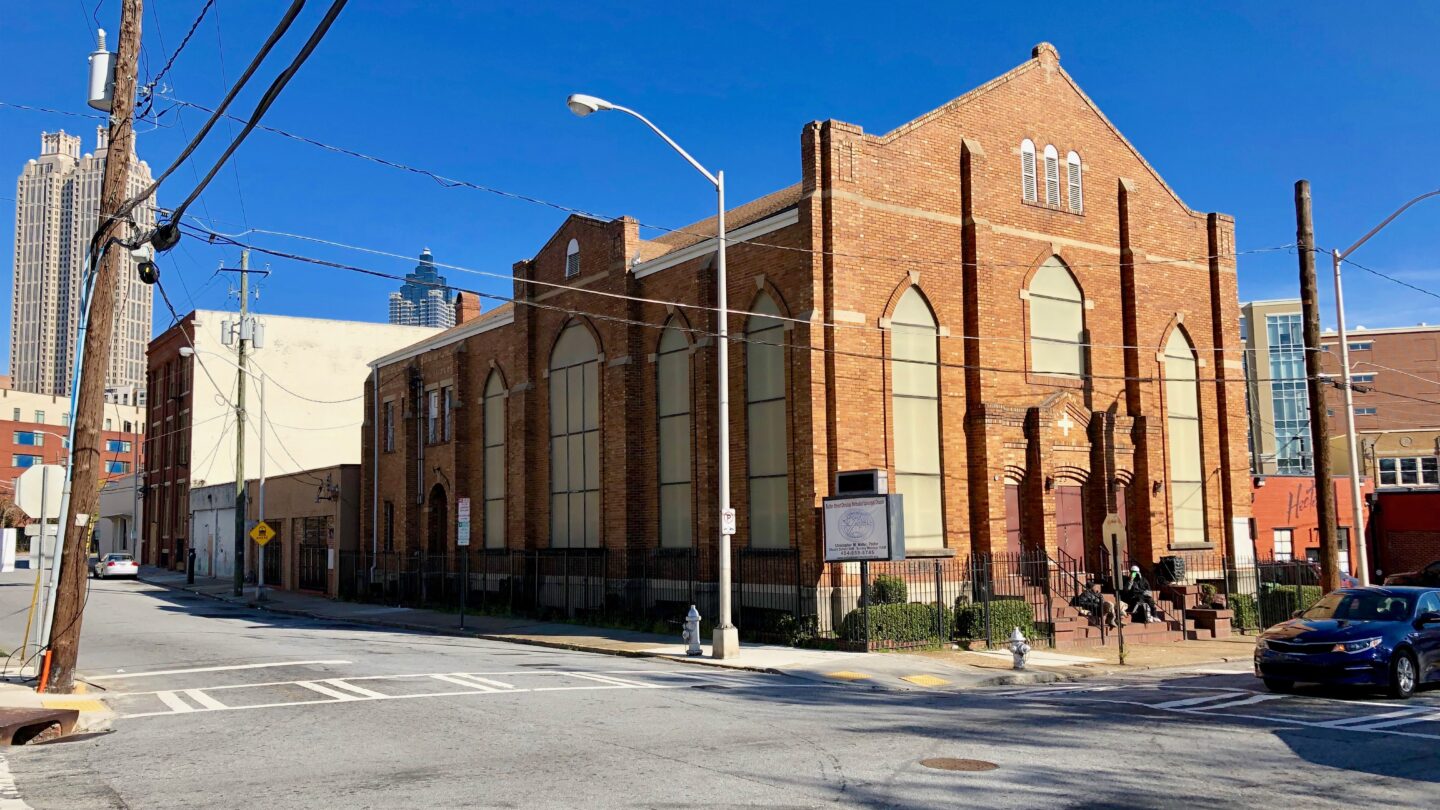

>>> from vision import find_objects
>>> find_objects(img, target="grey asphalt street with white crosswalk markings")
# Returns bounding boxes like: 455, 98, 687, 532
0, 571, 1440, 810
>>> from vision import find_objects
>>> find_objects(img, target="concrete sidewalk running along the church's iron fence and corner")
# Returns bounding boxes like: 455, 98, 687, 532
140, 566, 1249, 689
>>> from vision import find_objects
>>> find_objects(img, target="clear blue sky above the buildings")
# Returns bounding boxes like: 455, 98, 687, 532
0, 0, 1440, 366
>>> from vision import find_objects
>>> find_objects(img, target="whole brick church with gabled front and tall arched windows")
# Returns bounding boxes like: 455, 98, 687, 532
361, 43, 1250, 599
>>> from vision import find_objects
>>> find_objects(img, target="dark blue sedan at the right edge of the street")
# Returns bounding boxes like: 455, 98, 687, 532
1256, 585, 1440, 698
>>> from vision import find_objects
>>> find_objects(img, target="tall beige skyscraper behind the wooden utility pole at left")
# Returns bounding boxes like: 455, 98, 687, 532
10, 127, 156, 405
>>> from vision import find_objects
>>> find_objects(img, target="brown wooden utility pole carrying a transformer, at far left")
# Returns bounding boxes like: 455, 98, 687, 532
46, 0, 143, 693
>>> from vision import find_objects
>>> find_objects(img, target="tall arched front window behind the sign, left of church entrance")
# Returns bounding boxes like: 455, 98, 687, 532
890, 287, 945, 548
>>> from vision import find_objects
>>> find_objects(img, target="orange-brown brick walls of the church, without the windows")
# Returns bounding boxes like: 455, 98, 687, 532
361, 45, 1250, 575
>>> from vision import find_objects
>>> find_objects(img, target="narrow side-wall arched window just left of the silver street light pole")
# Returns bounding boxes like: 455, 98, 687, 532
655, 323, 691, 548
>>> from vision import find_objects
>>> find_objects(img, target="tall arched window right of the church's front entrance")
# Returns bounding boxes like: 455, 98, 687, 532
1165, 329, 1205, 545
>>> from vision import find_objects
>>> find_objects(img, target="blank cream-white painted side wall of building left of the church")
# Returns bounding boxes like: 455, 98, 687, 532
182, 310, 439, 487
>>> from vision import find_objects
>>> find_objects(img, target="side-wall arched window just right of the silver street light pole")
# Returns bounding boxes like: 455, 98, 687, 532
744, 293, 791, 548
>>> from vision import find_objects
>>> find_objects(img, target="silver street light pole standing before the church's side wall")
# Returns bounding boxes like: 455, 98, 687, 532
566, 94, 740, 659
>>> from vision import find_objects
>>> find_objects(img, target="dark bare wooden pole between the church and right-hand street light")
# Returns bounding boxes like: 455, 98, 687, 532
1295, 180, 1341, 592
